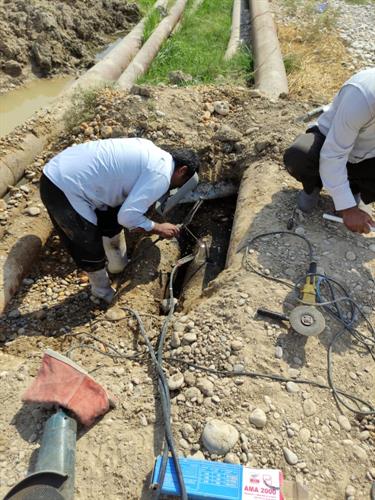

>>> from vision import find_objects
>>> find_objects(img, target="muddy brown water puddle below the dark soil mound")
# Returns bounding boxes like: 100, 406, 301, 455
0, 76, 73, 137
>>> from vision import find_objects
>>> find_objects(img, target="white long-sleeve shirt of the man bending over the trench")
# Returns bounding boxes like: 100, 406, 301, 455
43, 138, 174, 231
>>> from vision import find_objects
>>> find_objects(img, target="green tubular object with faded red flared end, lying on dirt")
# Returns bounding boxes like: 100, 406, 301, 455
4, 349, 110, 500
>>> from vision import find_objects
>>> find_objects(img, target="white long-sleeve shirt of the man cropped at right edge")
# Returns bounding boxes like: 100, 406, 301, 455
318, 68, 375, 210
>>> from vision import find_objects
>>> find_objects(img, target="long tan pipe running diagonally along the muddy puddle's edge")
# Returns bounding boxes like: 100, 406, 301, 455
0, 0, 167, 197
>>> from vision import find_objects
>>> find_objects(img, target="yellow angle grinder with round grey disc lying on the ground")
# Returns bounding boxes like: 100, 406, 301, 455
257, 262, 326, 337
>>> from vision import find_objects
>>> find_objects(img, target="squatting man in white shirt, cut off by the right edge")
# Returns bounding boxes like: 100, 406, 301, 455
284, 68, 375, 233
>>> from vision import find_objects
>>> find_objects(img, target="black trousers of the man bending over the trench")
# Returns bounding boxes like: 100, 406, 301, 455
40, 174, 123, 272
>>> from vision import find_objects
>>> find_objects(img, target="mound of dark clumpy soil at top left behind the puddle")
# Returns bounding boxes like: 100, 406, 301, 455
0, 0, 140, 92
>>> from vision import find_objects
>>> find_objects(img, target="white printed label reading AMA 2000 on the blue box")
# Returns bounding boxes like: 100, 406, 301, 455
241, 467, 283, 500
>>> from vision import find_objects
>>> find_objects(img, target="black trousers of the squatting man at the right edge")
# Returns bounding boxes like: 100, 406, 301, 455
284, 126, 375, 204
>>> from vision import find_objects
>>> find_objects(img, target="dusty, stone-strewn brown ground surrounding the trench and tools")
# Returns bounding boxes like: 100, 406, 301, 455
0, 87, 375, 500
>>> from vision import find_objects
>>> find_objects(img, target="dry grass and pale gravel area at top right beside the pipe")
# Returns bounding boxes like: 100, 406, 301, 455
270, 0, 375, 104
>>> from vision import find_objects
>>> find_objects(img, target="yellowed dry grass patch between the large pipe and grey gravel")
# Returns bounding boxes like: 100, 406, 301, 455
278, 24, 353, 102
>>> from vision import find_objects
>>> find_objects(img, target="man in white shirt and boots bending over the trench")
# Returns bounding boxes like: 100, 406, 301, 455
40, 138, 199, 302
